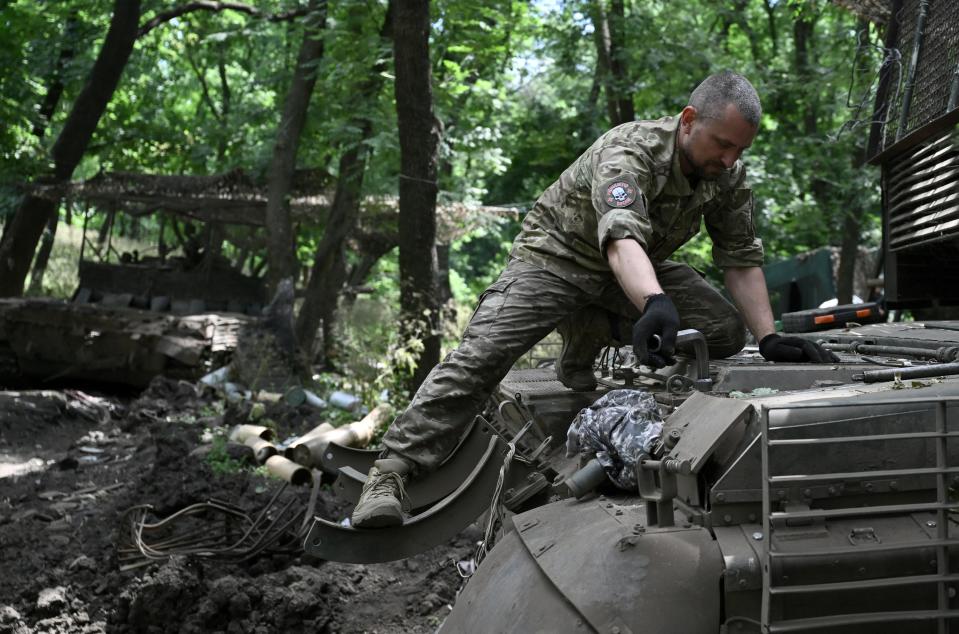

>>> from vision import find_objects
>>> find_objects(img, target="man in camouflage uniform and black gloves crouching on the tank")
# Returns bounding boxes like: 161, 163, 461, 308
352, 72, 836, 528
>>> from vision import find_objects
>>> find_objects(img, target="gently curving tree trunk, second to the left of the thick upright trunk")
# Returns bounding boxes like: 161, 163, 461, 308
266, 0, 327, 294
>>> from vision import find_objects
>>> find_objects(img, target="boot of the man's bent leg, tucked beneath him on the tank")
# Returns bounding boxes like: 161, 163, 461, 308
556, 306, 609, 392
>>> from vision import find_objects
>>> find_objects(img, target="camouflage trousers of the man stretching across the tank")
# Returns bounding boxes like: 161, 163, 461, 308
383, 259, 745, 473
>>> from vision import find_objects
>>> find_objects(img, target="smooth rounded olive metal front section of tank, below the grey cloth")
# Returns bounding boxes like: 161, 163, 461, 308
440, 498, 723, 634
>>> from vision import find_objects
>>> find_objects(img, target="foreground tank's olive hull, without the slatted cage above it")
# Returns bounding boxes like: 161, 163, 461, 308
441, 322, 959, 633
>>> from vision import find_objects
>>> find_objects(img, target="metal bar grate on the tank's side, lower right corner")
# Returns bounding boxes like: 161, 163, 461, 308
760, 397, 959, 633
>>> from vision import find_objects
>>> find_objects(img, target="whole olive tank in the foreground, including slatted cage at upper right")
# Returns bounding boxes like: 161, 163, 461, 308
305, 0, 959, 634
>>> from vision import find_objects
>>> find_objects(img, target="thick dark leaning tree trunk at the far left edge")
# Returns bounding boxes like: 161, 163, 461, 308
0, 0, 140, 297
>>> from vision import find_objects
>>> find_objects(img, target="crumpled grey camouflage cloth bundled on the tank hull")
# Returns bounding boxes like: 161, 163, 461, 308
566, 390, 663, 490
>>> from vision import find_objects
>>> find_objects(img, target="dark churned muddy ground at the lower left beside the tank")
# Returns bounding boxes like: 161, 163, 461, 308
0, 379, 479, 633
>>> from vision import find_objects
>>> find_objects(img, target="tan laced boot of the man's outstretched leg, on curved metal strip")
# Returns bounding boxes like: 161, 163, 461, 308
350, 458, 410, 528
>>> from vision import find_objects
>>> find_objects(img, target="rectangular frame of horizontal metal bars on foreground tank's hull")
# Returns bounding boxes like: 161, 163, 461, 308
761, 397, 959, 633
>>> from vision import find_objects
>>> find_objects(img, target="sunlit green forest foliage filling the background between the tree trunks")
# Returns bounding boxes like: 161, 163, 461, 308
0, 0, 883, 404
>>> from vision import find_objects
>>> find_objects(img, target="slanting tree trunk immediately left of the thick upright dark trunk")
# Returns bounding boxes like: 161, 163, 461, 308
296, 2, 393, 351
